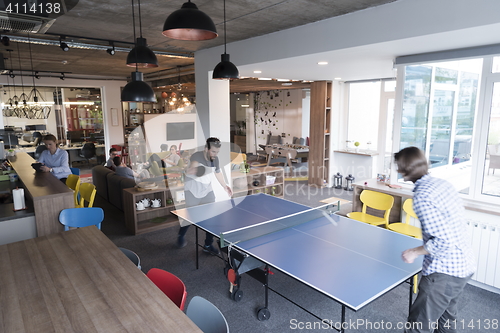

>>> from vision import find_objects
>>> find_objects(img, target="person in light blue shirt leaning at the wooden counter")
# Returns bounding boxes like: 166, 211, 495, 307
38, 134, 71, 183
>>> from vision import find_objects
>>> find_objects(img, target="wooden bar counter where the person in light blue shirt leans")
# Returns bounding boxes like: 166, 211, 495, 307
9, 153, 75, 236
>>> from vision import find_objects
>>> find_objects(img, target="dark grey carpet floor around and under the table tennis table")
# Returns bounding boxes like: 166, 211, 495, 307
95, 181, 500, 333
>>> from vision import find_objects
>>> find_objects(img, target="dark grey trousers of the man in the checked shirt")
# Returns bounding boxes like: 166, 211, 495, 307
405, 273, 470, 333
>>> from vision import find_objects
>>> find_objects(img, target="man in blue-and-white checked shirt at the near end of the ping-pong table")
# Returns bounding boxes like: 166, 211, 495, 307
394, 147, 476, 333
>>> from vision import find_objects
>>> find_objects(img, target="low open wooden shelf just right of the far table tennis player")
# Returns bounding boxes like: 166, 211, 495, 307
231, 167, 285, 198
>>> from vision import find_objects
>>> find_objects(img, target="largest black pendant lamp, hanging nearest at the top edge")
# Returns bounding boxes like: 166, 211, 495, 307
162, 0, 218, 40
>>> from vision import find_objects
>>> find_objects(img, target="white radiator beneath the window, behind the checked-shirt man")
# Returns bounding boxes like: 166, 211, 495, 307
467, 219, 500, 288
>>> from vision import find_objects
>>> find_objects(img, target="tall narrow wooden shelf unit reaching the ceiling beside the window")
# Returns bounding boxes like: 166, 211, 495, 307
308, 81, 332, 186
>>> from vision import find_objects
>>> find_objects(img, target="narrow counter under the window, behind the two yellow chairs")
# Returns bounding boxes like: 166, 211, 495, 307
352, 179, 413, 223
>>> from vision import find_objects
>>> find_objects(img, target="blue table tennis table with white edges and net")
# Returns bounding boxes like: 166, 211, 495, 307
173, 193, 422, 332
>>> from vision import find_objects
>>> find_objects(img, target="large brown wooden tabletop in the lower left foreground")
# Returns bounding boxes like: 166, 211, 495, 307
0, 226, 201, 333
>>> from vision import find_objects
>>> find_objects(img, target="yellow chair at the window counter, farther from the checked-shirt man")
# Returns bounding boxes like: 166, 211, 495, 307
347, 190, 394, 228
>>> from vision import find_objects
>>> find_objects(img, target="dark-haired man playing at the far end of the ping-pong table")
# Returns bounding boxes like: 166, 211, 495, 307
177, 137, 233, 254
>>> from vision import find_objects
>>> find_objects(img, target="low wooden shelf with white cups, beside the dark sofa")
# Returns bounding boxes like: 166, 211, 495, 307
123, 184, 185, 235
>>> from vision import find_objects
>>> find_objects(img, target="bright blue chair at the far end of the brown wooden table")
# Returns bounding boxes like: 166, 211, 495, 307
59, 207, 104, 231
